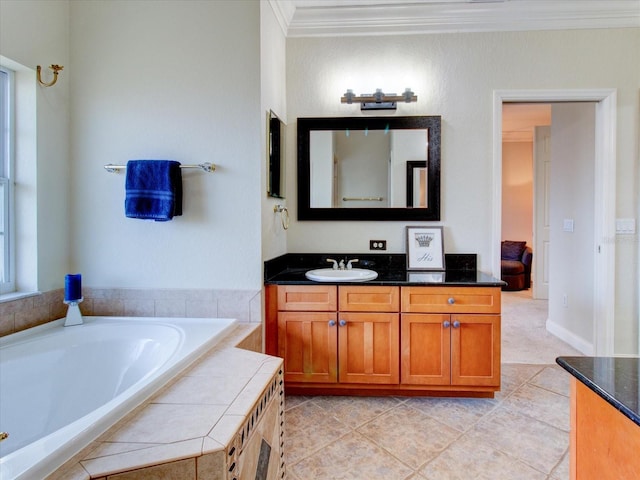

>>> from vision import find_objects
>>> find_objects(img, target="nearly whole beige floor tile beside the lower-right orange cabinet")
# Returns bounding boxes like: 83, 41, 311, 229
467, 407, 569, 474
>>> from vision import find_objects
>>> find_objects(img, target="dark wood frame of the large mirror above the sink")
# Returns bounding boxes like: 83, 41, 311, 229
298, 116, 441, 221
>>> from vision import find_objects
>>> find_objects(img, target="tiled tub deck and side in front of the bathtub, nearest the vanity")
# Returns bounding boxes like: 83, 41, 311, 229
47, 324, 284, 480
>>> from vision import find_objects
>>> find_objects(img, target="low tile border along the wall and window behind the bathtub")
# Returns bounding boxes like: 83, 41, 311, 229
0, 287, 262, 337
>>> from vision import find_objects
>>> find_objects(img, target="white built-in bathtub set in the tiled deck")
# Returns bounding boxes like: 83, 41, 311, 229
0, 317, 236, 480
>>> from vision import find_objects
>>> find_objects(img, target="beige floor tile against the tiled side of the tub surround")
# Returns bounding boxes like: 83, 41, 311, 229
284, 402, 351, 465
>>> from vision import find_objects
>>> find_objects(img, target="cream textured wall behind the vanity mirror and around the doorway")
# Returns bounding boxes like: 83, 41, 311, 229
287, 28, 640, 354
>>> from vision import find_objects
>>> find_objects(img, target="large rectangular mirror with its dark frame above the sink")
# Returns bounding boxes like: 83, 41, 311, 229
298, 116, 441, 221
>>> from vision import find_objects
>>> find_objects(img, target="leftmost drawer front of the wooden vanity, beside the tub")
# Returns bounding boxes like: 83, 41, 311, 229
278, 285, 338, 312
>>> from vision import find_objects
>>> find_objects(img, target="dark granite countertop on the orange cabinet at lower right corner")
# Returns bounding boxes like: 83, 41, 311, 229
556, 357, 640, 426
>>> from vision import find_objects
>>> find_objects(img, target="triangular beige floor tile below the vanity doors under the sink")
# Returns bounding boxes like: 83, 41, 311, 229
312, 397, 400, 428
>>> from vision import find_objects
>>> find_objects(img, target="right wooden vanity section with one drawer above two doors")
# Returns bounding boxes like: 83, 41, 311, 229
401, 287, 500, 387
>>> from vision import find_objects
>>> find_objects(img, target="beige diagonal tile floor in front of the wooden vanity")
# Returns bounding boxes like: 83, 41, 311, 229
285, 295, 569, 480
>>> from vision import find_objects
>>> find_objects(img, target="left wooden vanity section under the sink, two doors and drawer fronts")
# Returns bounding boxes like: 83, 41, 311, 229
277, 285, 400, 384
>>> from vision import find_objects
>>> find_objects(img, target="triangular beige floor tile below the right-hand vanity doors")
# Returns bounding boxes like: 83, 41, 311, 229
407, 397, 498, 432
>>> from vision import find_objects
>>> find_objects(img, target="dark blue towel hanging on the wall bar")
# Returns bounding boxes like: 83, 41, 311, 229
124, 160, 182, 222
